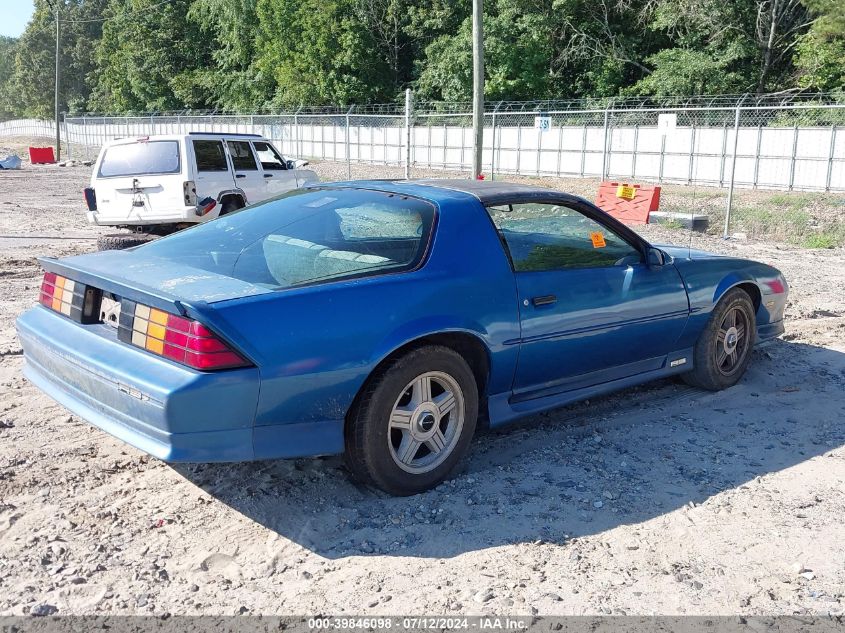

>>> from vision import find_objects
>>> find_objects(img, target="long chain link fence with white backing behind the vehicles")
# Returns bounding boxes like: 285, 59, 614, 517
0, 95, 845, 241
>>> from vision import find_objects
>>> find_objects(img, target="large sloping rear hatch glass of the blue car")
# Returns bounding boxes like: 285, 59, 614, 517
141, 189, 435, 288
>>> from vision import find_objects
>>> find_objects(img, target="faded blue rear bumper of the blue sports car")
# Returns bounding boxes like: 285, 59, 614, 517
17, 307, 259, 462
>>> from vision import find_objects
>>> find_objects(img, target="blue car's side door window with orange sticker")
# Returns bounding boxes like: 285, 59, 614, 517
487, 203, 642, 272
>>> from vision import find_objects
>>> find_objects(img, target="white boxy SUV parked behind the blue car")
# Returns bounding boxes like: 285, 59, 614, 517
85, 132, 319, 249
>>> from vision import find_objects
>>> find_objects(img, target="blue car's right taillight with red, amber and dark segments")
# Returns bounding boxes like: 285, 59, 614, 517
118, 299, 249, 371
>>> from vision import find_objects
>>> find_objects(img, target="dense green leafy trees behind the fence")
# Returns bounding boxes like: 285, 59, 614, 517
0, 0, 845, 117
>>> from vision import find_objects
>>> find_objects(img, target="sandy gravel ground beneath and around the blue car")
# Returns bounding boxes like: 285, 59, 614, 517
0, 140, 845, 615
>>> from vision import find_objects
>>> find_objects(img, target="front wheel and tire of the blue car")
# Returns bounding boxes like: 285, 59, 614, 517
682, 288, 757, 391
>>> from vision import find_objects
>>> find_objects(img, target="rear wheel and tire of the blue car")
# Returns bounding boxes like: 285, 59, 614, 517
344, 346, 478, 496
